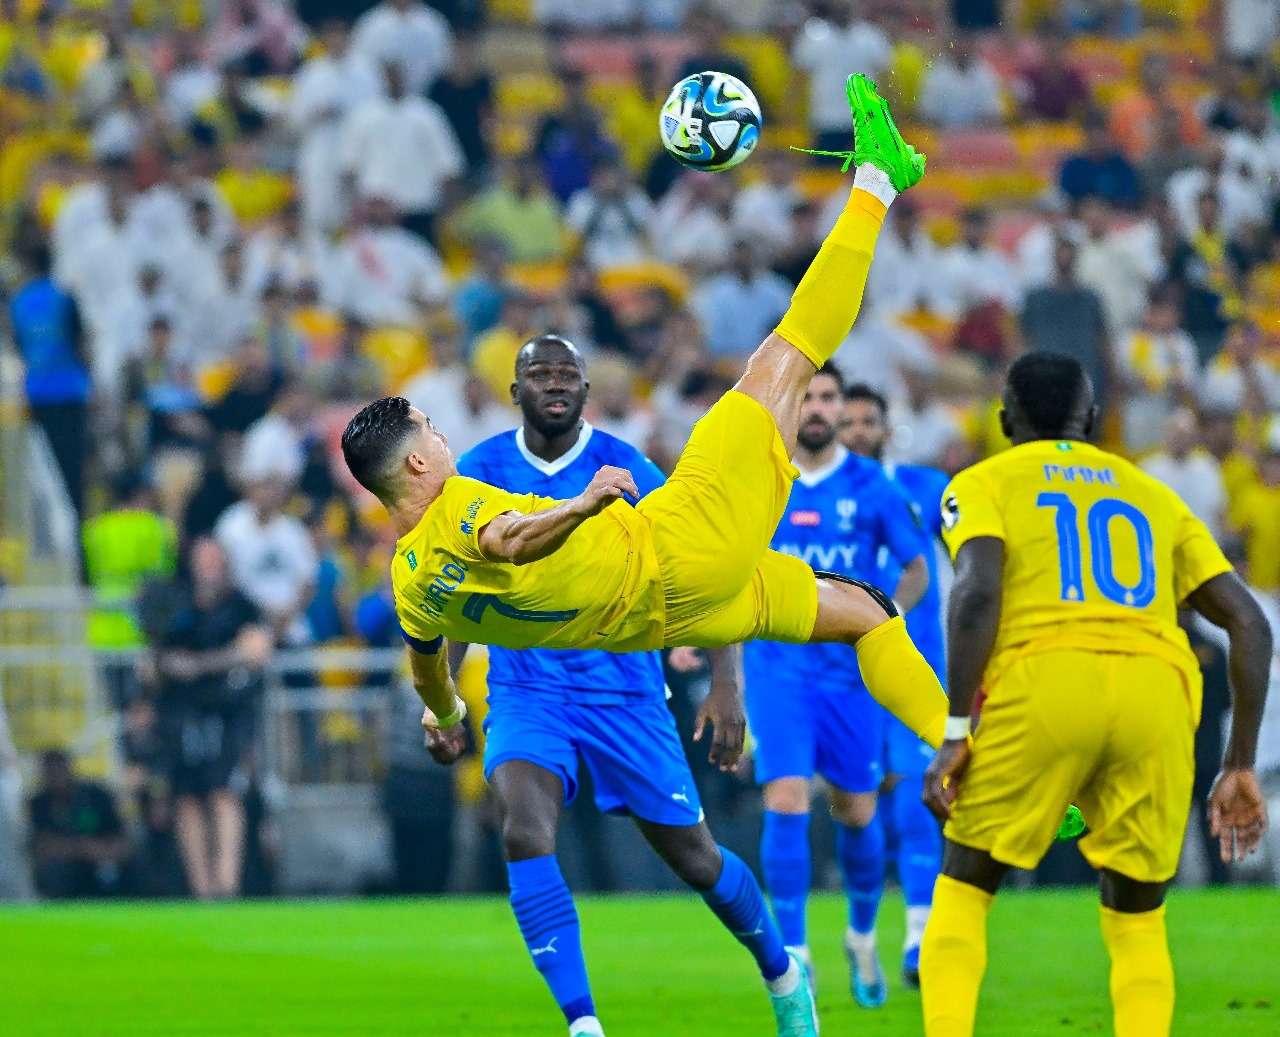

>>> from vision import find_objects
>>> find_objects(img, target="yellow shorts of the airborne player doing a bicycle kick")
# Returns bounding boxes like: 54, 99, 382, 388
637, 392, 818, 648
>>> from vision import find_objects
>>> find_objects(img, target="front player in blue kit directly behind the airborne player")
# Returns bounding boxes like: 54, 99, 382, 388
451, 335, 814, 1037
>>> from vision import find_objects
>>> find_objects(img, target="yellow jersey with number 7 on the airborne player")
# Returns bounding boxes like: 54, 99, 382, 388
392, 475, 666, 652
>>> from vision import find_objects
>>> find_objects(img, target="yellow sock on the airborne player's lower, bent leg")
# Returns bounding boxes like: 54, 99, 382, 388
854, 616, 947, 749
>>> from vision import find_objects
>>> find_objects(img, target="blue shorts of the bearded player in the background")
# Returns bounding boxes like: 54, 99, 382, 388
746, 641, 888, 792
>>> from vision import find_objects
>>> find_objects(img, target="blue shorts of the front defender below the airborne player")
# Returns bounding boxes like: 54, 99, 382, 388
484, 687, 703, 826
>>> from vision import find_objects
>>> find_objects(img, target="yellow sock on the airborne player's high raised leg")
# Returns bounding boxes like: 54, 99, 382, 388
774, 187, 887, 367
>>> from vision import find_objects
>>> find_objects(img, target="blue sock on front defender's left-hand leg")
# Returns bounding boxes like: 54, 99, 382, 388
507, 855, 595, 1023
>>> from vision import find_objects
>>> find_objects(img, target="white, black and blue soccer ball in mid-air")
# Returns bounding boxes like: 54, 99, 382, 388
658, 72, 764, 172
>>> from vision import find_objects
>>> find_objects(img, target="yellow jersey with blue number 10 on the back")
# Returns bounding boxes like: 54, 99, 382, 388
942, 440, 1231, 680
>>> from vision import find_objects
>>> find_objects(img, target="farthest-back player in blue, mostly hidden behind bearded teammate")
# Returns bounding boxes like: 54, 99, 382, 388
841, 385, 948, 987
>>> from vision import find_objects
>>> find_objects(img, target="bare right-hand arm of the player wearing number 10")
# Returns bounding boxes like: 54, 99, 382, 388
1187, 572, 1272, 863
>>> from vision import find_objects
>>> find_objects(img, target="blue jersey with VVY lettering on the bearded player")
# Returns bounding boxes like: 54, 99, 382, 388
746, 448, 931, 687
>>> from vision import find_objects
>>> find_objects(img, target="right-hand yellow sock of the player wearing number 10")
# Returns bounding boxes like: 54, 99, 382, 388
1102, 904, 1174, 1037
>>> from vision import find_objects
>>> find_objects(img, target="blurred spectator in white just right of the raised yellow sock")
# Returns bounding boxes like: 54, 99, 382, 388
867, 198, 955, 318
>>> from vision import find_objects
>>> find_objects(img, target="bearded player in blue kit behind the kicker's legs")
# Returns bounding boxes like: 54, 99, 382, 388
744, 364, 928, 1008
